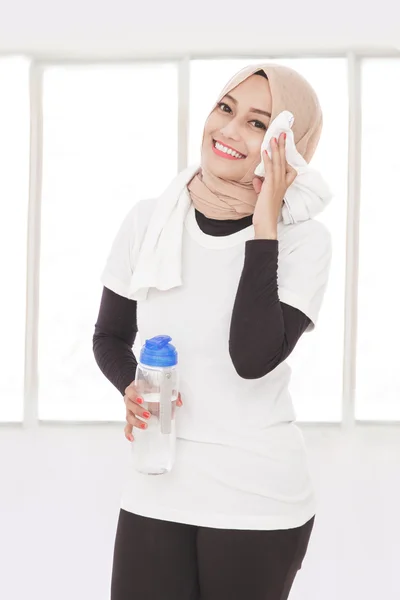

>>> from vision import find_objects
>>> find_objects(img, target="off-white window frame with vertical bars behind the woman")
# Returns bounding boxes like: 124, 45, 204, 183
0, 48, 400, 430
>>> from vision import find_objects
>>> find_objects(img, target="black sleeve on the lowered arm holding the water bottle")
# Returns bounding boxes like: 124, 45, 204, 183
93, 287, 137, 396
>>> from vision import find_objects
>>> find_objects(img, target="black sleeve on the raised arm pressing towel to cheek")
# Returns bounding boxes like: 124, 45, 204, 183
229, 239, 311, 379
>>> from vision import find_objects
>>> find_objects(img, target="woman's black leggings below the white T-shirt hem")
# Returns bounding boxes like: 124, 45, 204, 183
111, 509, 315, 600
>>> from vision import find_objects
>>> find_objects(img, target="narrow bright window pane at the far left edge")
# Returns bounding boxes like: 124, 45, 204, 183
0, 57, 30, 422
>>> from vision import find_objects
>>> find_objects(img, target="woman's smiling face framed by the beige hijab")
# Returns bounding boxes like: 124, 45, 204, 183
201, 75, 272, 181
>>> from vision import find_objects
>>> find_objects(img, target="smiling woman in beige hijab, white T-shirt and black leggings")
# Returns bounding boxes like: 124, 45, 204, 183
93, 65, 331, 600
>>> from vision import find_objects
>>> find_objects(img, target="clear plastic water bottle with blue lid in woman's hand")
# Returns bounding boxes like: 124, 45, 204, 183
132, 335, 179, 475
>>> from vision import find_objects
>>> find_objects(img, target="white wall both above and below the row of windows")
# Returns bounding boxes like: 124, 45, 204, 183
0, 0, 400, 600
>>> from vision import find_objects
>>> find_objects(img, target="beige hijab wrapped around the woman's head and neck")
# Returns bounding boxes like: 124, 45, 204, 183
188, 64, 322, 219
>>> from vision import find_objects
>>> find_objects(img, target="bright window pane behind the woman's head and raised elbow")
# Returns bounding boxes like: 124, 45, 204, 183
189, 58, 348, 421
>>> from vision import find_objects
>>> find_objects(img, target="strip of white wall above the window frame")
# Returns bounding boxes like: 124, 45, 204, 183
0, 0, 400, 56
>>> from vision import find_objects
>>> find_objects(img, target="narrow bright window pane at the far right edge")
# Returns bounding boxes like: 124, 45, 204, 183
356, 59, 400, 420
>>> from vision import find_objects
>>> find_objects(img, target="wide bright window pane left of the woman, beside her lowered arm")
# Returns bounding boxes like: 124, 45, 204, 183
39, 64, 178, 421
